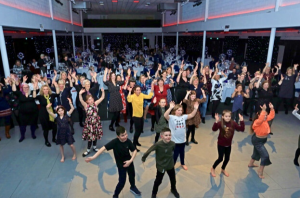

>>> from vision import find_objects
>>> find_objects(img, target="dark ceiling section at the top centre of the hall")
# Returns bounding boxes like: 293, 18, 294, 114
86, 0, 174, 15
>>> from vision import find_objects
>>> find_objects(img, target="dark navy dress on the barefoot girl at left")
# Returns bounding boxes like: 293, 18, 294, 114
55, 114, 75, 146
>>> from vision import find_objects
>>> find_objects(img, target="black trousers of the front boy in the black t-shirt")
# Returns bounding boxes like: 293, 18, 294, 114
114, 163, 135, 196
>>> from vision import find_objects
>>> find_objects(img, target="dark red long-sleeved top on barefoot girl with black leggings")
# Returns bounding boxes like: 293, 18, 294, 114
212, 120, 245, 146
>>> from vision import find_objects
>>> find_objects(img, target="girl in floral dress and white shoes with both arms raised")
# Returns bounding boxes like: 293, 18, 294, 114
79, 88, 105, 157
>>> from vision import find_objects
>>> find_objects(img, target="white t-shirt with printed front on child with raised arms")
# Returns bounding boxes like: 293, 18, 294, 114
169, 114, 188, 144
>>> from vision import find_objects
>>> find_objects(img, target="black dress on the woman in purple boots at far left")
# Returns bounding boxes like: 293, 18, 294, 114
14, 91, 38, 126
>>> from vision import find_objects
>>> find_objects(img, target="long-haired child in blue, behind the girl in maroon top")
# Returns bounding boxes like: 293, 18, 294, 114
231, 84, 249, 123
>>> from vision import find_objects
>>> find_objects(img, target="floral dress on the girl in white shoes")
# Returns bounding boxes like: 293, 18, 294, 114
82, 103, 103, 141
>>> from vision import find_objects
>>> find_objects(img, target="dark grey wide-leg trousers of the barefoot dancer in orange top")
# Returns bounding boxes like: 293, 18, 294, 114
251, 134, 272, 166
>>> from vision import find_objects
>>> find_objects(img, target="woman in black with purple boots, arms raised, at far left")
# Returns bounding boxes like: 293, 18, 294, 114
12, 80, 38, 142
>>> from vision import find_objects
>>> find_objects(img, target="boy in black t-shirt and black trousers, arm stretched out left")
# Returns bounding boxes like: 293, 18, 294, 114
85, 126, 141, 198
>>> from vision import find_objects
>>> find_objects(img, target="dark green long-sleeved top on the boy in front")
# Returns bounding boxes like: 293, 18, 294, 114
142, 140, 175, 173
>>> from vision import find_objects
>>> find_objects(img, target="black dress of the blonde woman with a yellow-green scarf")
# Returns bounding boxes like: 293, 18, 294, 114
36, 93, 58, 131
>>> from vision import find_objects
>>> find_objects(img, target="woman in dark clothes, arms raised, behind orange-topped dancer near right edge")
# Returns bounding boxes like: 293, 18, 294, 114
276, 63, 298, 114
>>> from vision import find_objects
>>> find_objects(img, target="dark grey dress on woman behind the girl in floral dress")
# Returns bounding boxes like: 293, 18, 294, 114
104, 81, 124, 112
